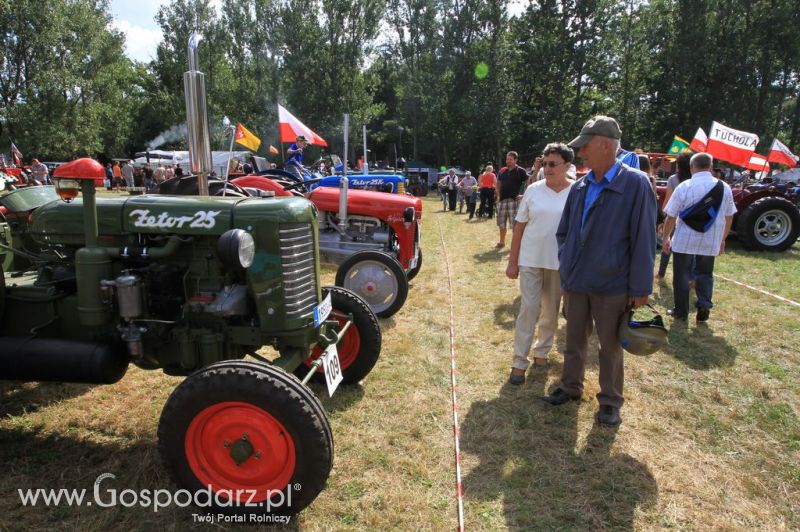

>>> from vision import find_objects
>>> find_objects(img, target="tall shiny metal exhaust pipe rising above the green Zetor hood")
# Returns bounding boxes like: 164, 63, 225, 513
183, 33, 212, 196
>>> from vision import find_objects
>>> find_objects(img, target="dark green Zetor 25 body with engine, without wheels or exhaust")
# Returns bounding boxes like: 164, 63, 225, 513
0, 189, 324, 374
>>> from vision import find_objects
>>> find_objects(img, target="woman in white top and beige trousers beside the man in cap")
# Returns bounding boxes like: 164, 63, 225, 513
506, 143, 574, 384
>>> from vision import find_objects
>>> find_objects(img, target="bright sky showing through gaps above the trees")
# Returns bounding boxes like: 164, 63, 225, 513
111, 0, 526, 62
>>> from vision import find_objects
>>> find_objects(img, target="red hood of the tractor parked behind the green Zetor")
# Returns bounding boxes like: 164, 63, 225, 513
310, 187, 422, 221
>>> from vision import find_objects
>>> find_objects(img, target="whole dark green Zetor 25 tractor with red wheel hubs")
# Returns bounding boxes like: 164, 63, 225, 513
0, 32, 381, 514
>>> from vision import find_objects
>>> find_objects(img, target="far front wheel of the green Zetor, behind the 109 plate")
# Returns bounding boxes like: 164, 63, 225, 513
295, 286, 382, 384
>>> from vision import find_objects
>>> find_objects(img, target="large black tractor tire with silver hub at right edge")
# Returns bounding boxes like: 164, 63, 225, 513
736, 196, 800, 251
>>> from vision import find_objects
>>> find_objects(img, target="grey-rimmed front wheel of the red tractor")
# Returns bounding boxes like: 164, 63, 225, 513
336, 251, 408, 318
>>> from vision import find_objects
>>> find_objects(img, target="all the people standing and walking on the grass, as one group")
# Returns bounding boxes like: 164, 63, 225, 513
439, 116, 735, 426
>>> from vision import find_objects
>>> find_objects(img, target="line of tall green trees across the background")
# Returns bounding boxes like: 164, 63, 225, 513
0, 0, 800, 168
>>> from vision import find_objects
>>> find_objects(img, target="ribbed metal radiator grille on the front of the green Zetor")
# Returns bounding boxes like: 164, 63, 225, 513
278, 223, 317, 319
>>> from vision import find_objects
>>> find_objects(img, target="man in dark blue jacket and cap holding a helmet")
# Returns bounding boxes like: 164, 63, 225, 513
543, 116, 657, 425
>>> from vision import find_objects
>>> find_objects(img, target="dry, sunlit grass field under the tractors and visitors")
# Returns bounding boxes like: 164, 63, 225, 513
0, 197, 800, 531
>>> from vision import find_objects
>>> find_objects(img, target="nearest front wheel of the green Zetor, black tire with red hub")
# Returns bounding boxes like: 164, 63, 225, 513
158, 360, 333, 515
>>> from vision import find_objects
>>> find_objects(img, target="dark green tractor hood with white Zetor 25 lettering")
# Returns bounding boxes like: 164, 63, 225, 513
30, 195, 309, 245
